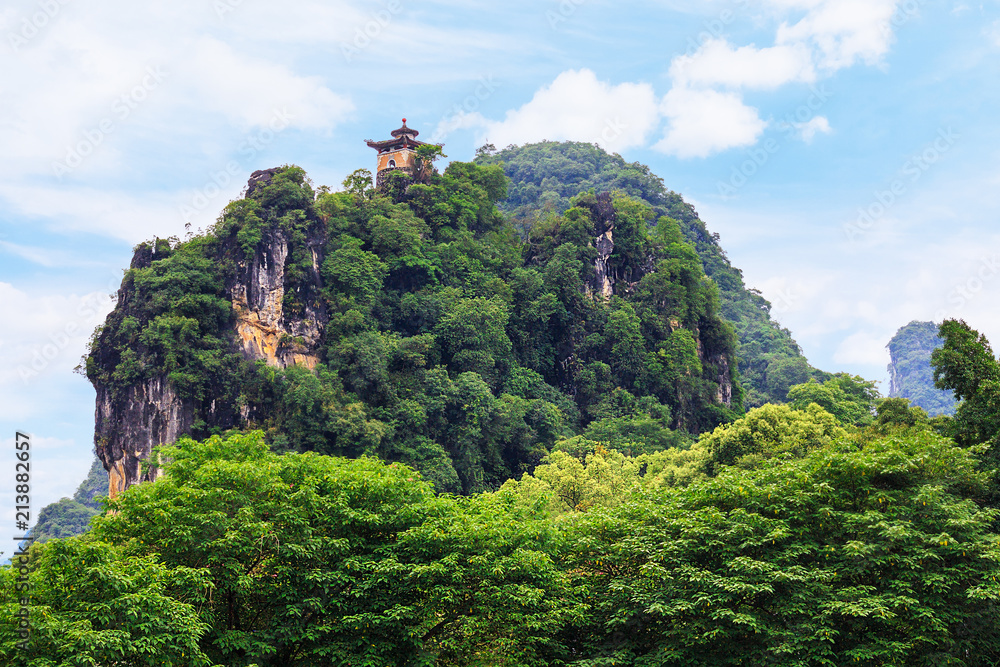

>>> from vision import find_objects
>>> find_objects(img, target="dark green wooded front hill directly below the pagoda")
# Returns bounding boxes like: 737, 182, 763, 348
87, 162, 744, 493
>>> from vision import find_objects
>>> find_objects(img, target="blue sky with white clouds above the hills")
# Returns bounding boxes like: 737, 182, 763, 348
0, 0, 1000, 548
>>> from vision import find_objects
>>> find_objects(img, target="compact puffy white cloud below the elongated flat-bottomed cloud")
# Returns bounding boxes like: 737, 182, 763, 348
654, 88, 767, 158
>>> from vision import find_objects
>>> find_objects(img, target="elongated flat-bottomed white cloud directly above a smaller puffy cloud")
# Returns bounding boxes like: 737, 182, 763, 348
670, 39, 816, 90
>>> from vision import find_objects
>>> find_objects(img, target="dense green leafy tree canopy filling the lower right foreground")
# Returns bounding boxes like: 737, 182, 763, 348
566, 432, 1000, 667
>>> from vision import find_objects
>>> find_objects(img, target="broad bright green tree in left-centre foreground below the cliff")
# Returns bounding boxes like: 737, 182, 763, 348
94, 433, 578, 667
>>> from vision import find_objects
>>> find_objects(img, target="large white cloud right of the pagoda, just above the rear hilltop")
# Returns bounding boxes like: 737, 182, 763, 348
435, 69, 660, 151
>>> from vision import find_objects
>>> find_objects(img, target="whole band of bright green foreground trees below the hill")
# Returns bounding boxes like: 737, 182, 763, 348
11, 426, 1000, 667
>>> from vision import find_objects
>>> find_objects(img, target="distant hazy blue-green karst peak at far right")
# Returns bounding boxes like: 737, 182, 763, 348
886, 321, 955, 416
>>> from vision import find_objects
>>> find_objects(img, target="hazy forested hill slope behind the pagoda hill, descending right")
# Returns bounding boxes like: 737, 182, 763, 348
476, 142, 829, 407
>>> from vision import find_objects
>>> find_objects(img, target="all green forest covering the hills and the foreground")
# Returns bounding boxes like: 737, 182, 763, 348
0, 149, 1000, 667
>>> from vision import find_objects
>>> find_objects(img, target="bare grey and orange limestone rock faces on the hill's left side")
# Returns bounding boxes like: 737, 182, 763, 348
91, 170, 327, 497
